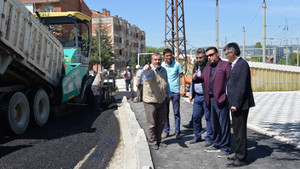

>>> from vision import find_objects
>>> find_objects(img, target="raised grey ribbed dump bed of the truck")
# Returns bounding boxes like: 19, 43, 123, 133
0, 0, 63, 89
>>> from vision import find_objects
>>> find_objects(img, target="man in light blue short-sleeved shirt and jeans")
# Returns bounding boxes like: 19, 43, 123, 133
162, 48, 185, 139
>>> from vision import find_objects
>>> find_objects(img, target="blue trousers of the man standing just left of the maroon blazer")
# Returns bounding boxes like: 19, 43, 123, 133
192, 94, 213, 141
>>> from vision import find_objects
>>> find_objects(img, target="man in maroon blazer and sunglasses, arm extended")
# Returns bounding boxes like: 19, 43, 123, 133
193, 47, 231, 157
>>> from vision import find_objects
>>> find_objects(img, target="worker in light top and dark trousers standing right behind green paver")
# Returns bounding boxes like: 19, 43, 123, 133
91, 69, 108, 111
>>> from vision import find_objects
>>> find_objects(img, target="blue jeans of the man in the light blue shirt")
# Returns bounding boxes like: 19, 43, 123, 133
164, 92, 180, 134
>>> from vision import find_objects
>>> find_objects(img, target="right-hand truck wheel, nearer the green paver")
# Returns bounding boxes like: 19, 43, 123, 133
32, 89, 50, 126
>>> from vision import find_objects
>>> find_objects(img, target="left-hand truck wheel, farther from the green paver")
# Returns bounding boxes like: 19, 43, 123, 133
7, 92, 30, 134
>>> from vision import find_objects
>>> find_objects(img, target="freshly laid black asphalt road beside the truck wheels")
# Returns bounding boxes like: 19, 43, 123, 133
0, 103, 120, 169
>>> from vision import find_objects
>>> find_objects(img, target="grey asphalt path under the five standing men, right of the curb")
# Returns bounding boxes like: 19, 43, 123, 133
129, 99, 300, 169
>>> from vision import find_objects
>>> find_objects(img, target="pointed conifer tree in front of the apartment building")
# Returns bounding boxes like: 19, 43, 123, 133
90, 19, 114, 69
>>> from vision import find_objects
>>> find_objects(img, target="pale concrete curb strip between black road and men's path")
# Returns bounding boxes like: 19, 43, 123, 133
118, 96, 154, 169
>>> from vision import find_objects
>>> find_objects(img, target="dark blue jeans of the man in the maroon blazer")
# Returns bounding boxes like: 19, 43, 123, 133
210, 98, 231, 152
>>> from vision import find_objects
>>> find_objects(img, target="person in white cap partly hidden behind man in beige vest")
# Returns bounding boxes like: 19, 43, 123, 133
133, 65, 143, 103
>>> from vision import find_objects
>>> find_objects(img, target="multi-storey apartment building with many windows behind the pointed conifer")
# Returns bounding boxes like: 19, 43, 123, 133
91, 9, 146, 70
